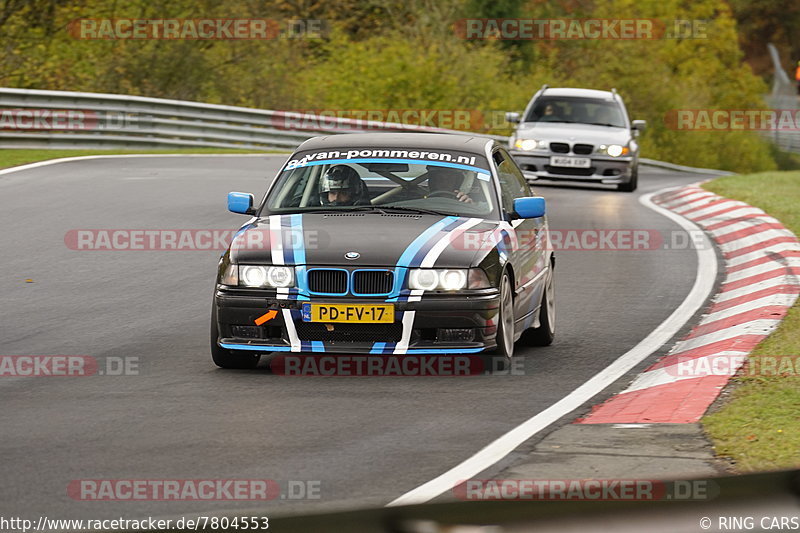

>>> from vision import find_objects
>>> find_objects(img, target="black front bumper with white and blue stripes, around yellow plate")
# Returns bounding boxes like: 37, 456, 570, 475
214, 286, 499, 354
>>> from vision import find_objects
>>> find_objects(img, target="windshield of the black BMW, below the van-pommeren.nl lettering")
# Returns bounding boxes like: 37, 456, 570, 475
265, 150, 496, 217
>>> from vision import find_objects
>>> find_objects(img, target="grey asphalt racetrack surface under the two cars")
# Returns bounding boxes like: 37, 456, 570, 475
0, 156, 712, 518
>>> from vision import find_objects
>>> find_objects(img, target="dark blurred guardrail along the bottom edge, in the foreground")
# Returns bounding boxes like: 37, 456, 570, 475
219, 470, 800, 533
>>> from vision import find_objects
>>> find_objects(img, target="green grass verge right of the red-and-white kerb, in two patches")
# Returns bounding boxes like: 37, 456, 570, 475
702, 171, 800, 472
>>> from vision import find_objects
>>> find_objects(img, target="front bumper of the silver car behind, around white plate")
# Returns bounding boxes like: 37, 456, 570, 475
510, 150, 635, 183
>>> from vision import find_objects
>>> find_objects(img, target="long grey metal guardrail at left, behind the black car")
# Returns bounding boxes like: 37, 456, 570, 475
0, 88, 507, 150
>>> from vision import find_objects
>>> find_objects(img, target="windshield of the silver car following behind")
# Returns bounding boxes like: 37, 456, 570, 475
525, 96, 627, 128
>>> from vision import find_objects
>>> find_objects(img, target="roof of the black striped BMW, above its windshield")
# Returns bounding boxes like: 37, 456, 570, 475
297, 132, 492, 155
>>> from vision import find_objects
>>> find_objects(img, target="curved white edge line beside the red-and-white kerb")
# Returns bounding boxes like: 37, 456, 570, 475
387, 187, 718, 507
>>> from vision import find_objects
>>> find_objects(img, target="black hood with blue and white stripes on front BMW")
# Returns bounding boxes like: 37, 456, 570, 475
231, 213, 507, 268
